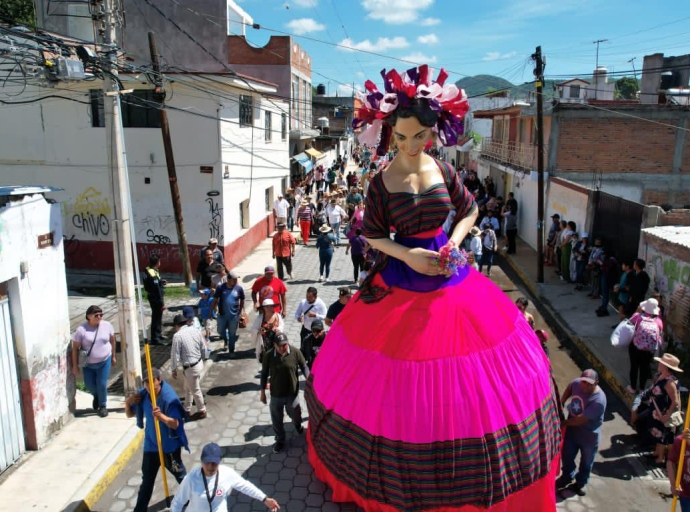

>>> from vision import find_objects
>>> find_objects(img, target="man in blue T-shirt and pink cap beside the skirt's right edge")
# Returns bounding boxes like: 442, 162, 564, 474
556, 369, 606, 496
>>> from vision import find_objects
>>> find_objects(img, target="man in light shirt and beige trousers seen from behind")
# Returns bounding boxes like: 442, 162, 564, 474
170, 315, 206, 420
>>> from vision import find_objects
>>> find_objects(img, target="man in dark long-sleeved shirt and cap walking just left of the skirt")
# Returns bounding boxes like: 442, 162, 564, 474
260, 333, 309, 453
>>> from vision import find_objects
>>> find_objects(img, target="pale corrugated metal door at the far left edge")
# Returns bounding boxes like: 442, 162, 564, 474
0, 299, 24, 473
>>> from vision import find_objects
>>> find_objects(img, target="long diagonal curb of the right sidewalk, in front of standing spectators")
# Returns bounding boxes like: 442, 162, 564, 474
502, 255, 632, 406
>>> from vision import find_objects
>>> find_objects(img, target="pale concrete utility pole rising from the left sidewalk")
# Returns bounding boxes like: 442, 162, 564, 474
102, 0, 141, 395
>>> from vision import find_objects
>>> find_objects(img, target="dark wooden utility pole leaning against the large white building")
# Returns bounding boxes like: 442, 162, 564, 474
149, 32, 192, 286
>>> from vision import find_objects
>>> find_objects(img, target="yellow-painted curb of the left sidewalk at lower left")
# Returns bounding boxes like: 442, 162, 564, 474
62, 426, 144, 512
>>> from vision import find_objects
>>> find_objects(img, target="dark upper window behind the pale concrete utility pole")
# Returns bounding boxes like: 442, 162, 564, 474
89, 89, 161, 128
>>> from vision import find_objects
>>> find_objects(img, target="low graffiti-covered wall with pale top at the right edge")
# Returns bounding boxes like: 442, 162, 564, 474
642, 228, 690, 346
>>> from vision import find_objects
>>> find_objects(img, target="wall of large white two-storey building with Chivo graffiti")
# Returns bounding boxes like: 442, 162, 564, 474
0, 77, 289, 269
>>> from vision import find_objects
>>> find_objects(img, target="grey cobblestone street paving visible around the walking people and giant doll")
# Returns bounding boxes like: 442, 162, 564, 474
94, 237, 668, 512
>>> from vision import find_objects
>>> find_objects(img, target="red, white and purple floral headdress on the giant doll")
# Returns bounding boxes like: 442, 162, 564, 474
352, 64, 470, 156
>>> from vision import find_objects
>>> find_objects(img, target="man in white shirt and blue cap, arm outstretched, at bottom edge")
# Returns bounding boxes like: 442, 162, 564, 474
170, 443, 280, 512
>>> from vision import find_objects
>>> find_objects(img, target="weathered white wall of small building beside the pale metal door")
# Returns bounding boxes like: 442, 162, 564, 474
0, 194, 74, 449
